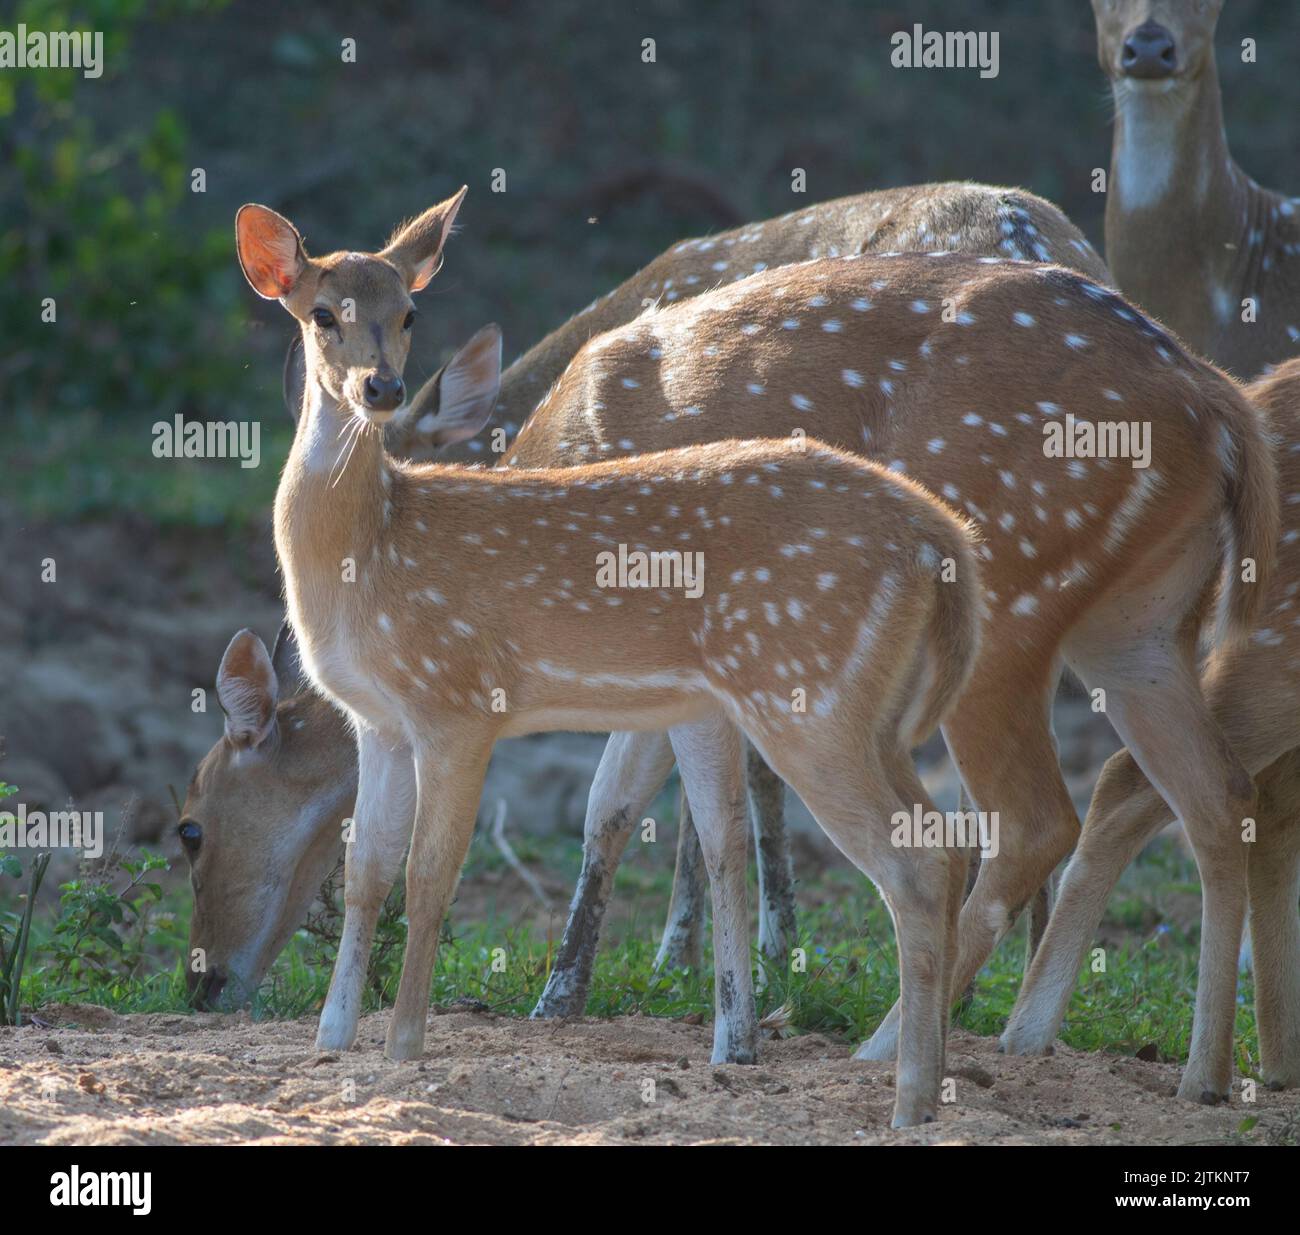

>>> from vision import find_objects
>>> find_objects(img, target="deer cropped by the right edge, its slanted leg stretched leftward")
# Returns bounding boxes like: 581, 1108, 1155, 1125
1002, 360, 1300, 1087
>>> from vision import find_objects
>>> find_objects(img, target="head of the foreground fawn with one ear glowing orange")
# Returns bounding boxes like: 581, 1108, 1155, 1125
235, 189, 465, 424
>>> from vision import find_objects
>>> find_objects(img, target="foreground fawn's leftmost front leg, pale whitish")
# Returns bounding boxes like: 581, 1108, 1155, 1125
316, 728, 416, 1050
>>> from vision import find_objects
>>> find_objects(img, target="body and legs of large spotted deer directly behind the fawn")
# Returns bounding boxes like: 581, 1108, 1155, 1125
491, 246, 1278, 1099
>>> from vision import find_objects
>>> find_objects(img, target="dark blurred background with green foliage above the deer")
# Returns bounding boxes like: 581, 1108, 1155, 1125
0, 0, 1300, 524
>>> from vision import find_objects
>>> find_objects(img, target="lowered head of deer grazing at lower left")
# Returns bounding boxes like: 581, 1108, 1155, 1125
178, 631, 356, 1010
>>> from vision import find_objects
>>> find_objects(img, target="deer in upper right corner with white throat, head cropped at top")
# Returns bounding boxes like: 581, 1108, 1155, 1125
1092, 0, 1300, 378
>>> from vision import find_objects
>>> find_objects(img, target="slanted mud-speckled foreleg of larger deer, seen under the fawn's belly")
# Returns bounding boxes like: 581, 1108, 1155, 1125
532, 732, 672, 1018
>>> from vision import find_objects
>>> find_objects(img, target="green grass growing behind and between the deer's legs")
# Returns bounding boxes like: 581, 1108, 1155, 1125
10, 837, 1258, 1075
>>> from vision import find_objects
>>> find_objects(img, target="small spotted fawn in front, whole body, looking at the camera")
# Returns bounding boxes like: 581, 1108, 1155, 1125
237, 189, 980, 1127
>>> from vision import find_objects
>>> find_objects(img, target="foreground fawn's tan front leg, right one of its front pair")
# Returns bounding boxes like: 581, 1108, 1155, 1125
384, 725, 493, 1060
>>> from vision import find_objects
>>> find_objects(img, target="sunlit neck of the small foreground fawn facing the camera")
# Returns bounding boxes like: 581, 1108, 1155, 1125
276, 376, 393, 633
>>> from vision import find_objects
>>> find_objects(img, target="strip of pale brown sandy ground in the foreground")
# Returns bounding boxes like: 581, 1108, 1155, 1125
0, 1006, 1300, 1145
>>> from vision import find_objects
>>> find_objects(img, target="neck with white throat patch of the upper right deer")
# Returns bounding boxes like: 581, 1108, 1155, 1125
1106, 62, 1251, 335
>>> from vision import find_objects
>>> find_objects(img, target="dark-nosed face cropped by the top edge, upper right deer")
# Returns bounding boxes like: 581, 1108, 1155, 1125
1092, 0, 1223, 91
